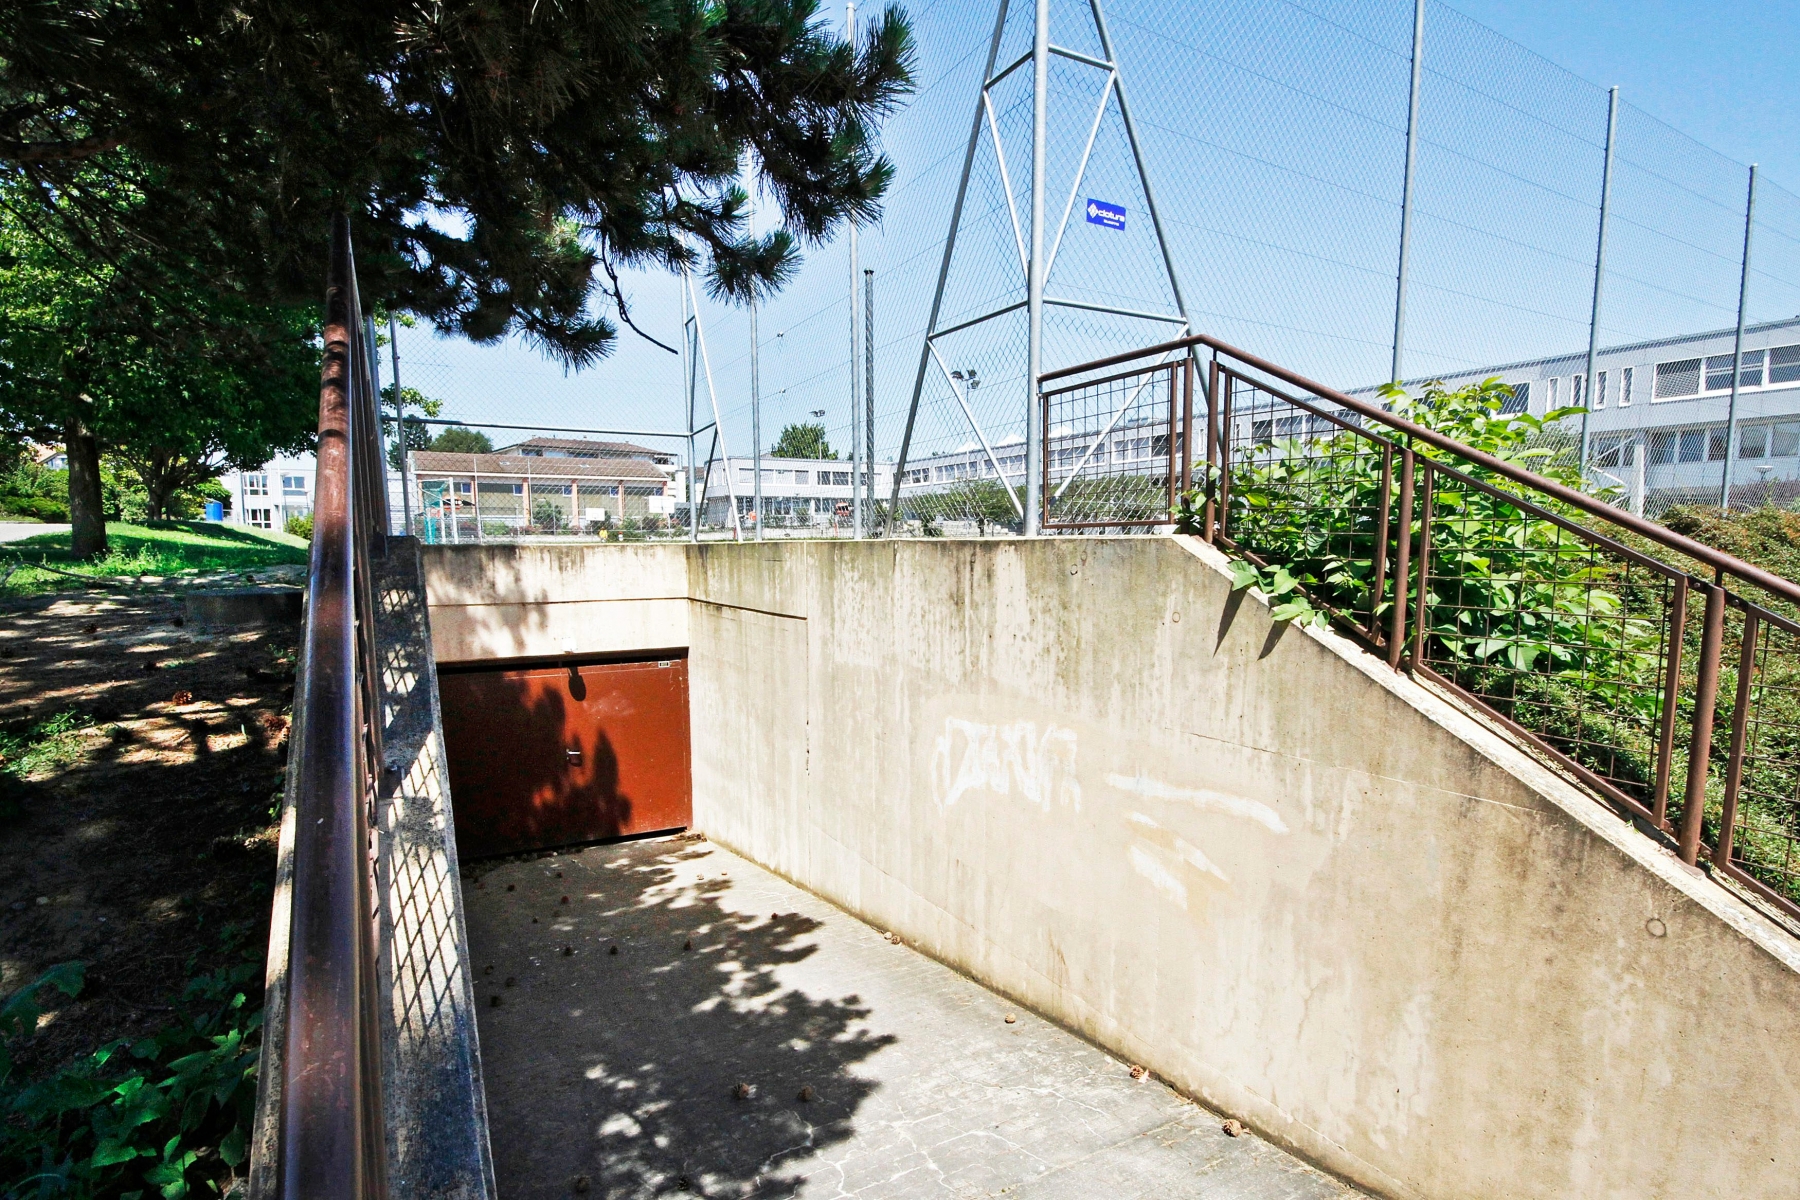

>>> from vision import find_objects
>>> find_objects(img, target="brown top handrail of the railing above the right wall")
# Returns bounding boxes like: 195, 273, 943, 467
1040, 335, 1800, 604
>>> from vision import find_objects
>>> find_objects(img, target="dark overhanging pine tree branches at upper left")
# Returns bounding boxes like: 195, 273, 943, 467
0, 0, 913, 367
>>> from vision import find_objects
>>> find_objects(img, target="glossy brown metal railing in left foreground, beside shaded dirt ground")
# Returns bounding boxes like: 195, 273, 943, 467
275, 218, 387, 1200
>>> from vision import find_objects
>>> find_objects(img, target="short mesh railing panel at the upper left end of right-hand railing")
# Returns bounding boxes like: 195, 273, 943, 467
1044, 360, 1188, 529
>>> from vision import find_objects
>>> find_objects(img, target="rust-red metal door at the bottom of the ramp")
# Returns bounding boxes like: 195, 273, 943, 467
437, 658, 693, 858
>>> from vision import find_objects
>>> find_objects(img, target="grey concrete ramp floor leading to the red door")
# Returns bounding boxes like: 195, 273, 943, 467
464, 838, 1357, 1200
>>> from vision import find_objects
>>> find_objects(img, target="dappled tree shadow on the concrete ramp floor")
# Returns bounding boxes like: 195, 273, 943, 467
464, 840, 893, 1200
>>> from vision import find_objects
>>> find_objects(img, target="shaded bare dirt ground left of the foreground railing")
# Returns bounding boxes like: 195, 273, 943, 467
0, 575, 299, 1076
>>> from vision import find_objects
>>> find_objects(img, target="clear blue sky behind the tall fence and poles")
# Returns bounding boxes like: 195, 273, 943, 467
401, 0, 1800, 457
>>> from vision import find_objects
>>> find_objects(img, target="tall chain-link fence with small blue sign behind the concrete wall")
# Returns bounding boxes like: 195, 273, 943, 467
369, 0, 1800, 536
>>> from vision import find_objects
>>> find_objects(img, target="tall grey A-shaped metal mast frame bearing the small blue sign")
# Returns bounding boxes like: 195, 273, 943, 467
869, 0, 1192, 536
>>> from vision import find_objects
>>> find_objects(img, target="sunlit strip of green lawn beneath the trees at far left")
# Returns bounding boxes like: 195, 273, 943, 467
0, 522, 306, 594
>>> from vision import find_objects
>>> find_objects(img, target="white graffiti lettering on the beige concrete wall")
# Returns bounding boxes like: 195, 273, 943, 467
931, 716, 1082, 811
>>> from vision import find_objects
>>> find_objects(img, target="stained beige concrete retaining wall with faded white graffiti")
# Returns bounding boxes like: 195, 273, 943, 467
427, 538, 1800, 1200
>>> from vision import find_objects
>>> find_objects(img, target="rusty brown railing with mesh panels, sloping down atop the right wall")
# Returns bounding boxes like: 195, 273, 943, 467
1040, 336, 1800, 918
